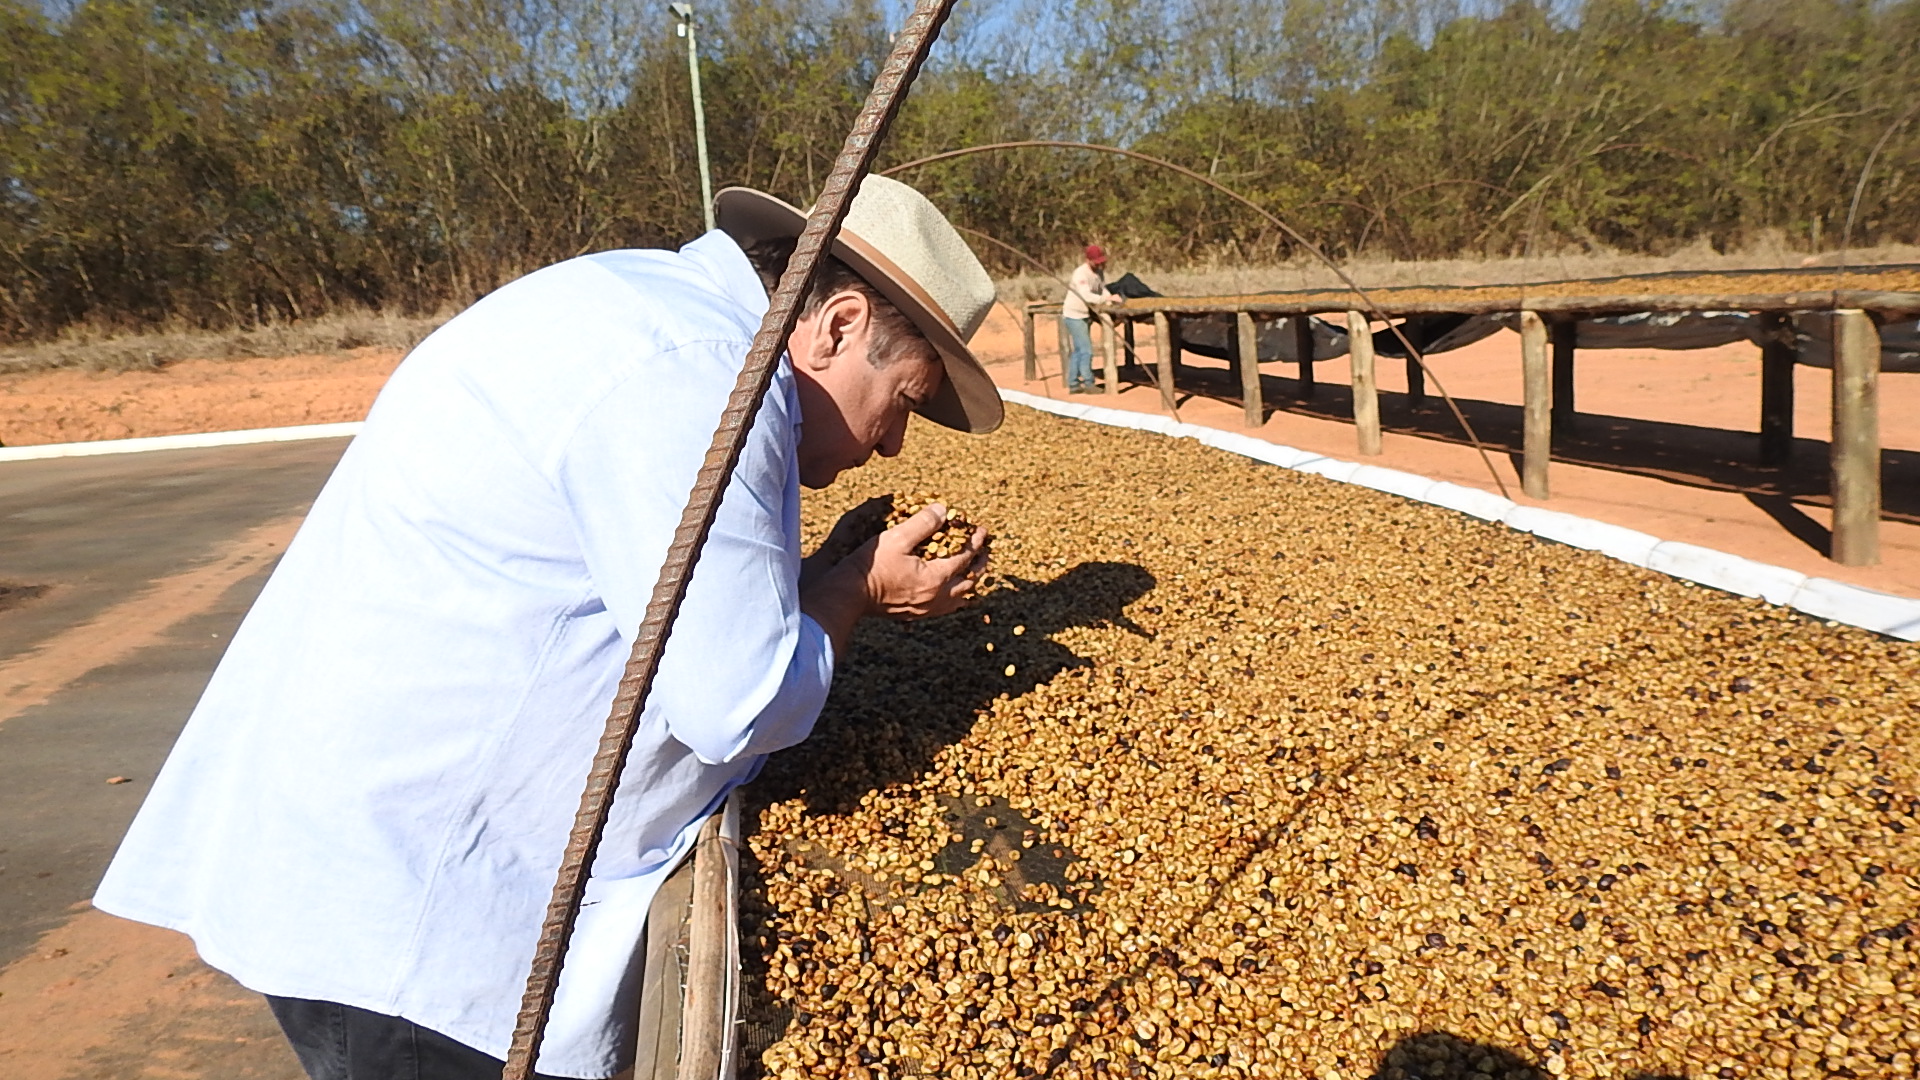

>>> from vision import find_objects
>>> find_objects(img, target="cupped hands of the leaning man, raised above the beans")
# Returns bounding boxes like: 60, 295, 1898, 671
801, 503, 989, 655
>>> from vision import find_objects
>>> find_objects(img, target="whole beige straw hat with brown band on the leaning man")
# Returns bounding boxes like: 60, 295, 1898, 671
714, 175, 1002, 434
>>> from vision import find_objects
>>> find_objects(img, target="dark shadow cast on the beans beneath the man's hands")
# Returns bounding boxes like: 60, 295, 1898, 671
749, 561, 1154, 815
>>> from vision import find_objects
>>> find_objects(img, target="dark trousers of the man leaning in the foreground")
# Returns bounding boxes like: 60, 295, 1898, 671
267, 994, 568, 1080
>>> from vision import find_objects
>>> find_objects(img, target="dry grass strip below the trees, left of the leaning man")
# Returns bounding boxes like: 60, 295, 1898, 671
0, 311, 451, 375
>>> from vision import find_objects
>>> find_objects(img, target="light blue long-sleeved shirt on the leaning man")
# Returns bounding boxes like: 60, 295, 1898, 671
94, 233, 833, 1076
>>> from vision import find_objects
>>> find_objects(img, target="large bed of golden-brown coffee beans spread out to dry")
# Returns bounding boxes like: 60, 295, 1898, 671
741, 407, 1920, 1080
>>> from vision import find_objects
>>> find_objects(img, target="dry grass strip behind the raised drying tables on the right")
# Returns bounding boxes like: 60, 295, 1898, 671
1000, 242, 1920, 304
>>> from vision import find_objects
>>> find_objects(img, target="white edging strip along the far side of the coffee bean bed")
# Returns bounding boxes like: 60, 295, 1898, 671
1000, 390, 1920, 642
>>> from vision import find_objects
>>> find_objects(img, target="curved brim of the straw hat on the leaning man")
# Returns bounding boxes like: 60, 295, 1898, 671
714, 188, 1006, 434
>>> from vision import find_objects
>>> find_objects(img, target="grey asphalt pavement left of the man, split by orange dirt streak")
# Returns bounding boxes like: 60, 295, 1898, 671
0, 438, 348, 965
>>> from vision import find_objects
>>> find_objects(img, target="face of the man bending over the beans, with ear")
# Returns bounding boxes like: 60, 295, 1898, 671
787, 292, 947, 488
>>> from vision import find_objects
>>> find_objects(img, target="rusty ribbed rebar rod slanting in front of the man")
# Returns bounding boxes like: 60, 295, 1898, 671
501, 0, 954, 1080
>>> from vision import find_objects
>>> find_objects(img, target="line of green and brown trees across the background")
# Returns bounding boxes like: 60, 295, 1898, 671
0, 0, 1920, 340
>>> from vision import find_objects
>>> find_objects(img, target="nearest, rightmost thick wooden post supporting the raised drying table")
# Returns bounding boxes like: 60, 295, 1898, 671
1828, 307, 1880, 567
